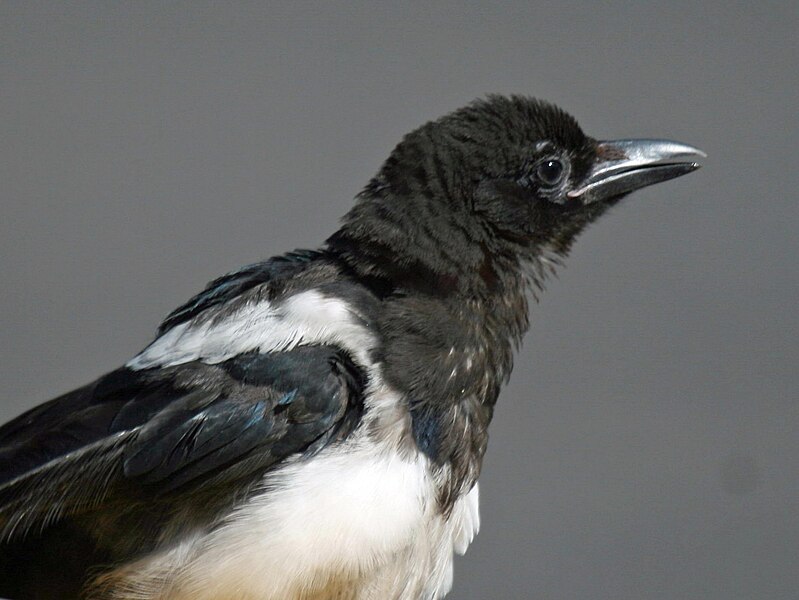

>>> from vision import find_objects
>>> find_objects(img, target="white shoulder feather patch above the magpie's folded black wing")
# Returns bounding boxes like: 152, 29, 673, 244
126, 290, 373, 370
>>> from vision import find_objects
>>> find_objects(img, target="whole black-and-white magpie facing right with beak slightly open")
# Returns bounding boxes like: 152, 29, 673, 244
0, 95, 705, 600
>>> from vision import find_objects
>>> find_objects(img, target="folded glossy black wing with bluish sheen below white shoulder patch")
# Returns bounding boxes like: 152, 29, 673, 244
0, 330, 363, 539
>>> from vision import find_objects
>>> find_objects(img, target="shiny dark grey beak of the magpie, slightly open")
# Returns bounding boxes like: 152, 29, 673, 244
567, 140, 707, 204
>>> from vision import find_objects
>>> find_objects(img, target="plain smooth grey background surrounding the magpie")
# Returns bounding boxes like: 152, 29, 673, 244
0, 2, 799, 600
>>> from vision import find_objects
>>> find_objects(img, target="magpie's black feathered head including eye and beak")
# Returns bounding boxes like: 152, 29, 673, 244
329, 96, 704, 293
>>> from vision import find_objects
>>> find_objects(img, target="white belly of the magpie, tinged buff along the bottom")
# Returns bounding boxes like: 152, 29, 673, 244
97, 441, 479, 600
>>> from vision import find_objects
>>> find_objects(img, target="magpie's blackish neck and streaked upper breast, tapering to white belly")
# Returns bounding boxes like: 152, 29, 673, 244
327, 199, 540, 506
